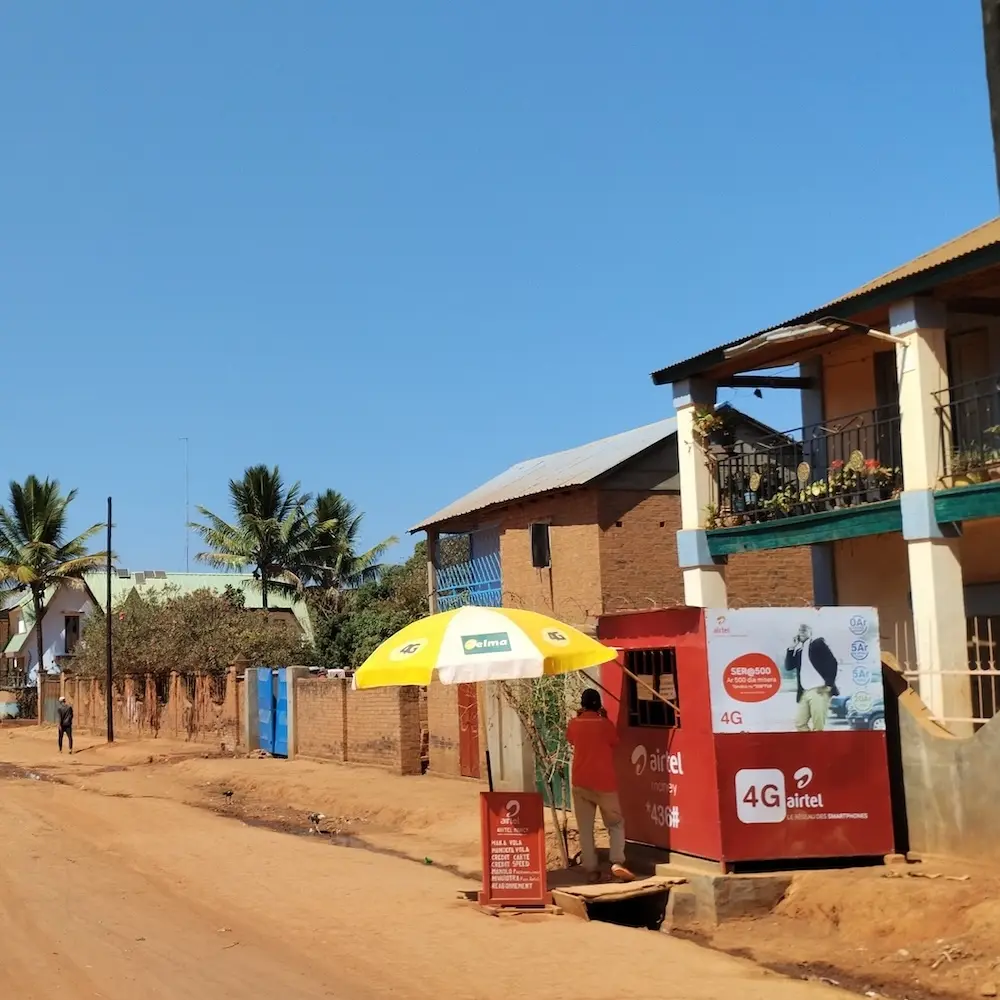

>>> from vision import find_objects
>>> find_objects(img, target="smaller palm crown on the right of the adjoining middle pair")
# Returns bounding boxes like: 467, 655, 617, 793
305, 490, 399, 589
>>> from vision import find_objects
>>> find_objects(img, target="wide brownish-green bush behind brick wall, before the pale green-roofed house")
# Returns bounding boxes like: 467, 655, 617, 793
74, 587, 315, 676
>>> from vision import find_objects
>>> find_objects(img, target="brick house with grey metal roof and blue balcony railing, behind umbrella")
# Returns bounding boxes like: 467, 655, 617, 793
412, 402, 813, 628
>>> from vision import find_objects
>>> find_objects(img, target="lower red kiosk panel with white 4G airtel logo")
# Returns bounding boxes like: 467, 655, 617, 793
715, 731, 893, 861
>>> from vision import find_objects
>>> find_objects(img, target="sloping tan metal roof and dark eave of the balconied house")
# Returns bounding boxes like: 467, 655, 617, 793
652, 216, 1000, 385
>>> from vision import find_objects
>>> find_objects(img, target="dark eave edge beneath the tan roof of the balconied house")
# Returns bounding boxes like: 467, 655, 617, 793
650, 242, 1000, 385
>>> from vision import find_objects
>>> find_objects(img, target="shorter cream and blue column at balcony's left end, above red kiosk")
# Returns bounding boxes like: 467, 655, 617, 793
674, 380, 729, 608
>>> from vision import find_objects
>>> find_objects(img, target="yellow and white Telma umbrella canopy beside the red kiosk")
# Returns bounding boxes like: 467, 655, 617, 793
354, 607, 617, 688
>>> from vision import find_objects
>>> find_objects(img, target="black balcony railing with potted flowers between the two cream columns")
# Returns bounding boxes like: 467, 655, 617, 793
707, 406, 903, 528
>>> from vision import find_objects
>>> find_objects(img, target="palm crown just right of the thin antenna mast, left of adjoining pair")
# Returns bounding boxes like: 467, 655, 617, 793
191, 465, 315, 610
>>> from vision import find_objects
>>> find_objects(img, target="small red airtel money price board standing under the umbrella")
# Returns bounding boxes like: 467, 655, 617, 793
479, 792, 549, 906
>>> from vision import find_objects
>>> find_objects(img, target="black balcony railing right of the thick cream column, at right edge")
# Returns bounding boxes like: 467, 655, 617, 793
934, 375, 1000, 486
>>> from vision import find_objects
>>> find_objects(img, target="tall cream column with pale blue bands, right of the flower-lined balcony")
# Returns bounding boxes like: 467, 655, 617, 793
889, 299, 972, 735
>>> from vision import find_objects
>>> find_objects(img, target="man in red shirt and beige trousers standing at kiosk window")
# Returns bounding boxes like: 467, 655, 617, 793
566, 688, 633, 882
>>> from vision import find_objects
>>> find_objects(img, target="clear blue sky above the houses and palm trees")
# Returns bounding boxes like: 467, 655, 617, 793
0, 0, 997, 570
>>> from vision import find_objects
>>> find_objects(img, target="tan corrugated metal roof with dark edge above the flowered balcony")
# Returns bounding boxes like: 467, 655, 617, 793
652, 216, 1000, 385
